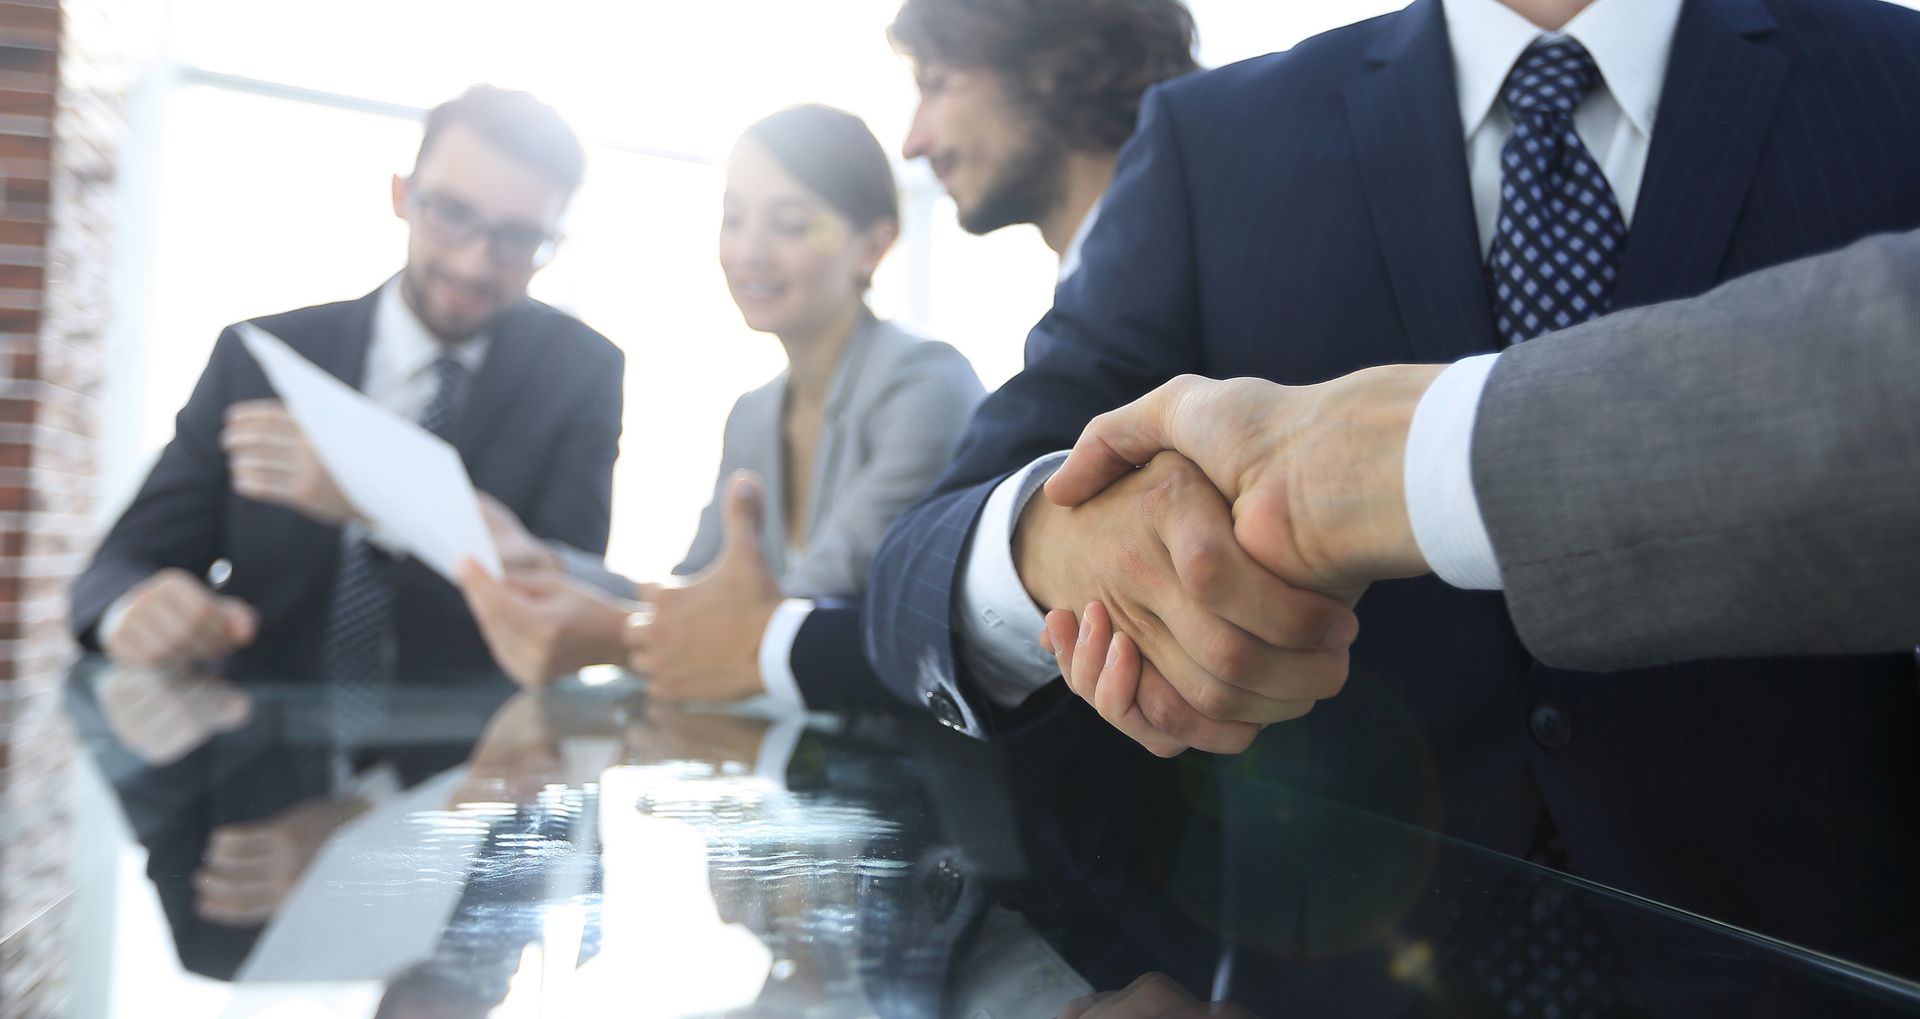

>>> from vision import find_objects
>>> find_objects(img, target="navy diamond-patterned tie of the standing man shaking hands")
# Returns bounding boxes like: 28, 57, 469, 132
1488, 38, 1626, 345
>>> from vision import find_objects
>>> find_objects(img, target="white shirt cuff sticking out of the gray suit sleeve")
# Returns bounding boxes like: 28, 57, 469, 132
1405, 353, 1503, 591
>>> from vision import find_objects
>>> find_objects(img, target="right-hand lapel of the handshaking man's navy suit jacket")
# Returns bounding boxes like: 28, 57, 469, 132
1613, 0, 1791, 307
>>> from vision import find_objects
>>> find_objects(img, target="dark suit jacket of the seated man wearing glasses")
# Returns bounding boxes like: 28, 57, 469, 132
71, 292, 624, 679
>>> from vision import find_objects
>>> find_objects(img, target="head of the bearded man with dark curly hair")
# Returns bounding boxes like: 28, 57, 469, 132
887, 0, 1198, 278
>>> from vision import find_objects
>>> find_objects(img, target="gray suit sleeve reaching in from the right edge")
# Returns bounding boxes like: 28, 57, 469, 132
1473, 232, 1920, 672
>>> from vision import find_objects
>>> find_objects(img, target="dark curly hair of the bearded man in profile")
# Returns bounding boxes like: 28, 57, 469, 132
887, 0, 1200, 152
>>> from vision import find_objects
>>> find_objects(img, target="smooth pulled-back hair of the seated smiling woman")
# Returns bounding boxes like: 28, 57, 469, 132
745, 106, 900, 230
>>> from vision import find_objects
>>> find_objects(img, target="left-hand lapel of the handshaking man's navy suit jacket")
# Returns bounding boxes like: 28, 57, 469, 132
1346, 0, 1494, 361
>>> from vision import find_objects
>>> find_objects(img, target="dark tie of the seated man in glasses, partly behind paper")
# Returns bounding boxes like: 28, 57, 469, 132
321, 355, 467, 748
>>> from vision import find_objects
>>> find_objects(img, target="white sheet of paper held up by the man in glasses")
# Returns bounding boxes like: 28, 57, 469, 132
236, 322, 501, 581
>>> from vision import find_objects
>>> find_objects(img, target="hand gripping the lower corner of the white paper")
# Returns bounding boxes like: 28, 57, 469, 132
461, 562, 626, 689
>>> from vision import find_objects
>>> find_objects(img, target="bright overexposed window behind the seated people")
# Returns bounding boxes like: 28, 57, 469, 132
96, 0, 1402, 578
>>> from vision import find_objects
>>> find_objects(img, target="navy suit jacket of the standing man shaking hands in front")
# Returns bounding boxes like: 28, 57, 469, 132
866, 0, 1920, 973
